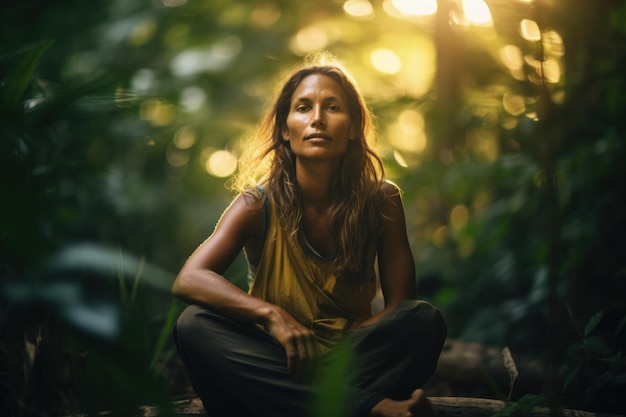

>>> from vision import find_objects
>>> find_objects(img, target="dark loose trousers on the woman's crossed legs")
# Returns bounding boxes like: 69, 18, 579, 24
174, 300, 447, 417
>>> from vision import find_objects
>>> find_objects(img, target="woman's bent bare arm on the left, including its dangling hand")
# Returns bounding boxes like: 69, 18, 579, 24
172, 195, 319, 380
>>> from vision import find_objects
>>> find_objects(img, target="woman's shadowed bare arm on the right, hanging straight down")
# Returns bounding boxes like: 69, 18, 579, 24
362, 183, 416, 326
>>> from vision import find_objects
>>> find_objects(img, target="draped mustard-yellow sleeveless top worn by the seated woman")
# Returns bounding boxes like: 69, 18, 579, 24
249, 200, 376, 351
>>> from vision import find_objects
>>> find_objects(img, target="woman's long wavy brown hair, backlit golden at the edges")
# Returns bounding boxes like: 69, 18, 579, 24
232, 55, 384, 277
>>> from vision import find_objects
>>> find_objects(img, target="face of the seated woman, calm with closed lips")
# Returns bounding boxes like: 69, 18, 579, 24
282, 74, 356, 160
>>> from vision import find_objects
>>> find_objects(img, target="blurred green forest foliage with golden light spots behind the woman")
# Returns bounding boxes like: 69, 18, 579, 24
0, 0, 626, 415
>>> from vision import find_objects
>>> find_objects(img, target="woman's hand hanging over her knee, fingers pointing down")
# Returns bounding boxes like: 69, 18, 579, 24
265, 306, 320, 382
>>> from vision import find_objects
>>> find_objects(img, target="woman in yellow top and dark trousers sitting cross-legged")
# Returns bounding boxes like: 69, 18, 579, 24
172, 55, 446, 417
